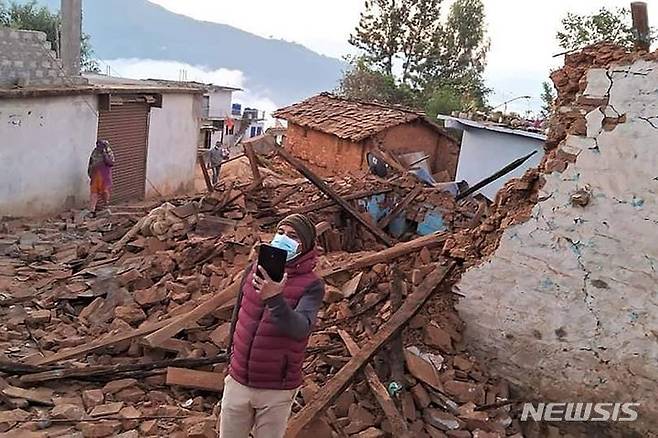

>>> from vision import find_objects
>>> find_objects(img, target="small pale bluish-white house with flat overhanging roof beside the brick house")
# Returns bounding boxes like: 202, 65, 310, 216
439, 115, 546, 200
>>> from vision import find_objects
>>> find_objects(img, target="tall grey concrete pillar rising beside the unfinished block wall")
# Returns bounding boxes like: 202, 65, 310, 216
61, 0, 82, 76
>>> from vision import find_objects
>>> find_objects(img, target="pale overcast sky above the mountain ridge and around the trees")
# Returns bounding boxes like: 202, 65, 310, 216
146, 0, 658, 111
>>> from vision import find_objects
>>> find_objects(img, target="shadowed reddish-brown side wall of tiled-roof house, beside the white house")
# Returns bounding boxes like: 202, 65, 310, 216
369, 122, 459, 179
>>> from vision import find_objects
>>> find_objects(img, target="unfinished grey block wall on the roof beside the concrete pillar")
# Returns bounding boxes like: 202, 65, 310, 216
0, 27, 86, 88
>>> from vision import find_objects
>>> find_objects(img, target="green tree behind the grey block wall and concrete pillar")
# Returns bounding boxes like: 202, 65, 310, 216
0, 0, 100, 72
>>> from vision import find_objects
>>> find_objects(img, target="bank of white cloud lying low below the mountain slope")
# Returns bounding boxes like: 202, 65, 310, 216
101, 58, 279, 123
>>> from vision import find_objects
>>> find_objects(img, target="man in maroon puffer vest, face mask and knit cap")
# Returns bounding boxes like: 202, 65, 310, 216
219, 214, 324, 438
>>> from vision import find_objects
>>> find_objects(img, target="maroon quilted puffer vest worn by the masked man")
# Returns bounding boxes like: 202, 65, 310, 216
229, 251, 320, 389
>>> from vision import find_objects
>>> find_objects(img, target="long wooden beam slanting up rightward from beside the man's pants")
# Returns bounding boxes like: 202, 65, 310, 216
285, 263, 455, 438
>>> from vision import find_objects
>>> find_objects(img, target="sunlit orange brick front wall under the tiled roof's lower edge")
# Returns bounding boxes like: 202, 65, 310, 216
285, 123, 364, 176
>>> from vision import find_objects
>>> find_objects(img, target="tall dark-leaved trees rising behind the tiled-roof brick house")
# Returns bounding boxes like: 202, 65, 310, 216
339, 0, 489, 113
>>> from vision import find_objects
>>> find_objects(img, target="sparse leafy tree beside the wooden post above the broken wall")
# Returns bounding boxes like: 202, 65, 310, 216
557, 7, 655, 50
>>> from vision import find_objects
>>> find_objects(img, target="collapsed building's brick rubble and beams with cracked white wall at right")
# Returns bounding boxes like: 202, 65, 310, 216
0, 42, 658, 438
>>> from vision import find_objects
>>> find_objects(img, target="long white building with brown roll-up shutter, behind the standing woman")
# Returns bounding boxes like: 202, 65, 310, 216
0, 75, 205, 217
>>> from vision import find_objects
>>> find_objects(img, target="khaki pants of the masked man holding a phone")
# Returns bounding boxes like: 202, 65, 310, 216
218, 376, 299, 438
